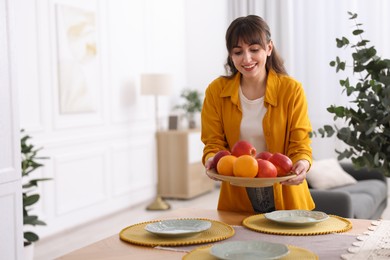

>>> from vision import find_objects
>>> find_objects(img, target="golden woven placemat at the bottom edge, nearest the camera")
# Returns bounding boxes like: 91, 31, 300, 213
183, 245, 319, 260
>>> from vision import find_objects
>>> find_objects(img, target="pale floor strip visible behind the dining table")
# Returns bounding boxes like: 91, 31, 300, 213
34, 180, 390, 260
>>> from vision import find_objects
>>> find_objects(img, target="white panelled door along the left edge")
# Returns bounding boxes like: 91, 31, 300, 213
0, 0, 23, 259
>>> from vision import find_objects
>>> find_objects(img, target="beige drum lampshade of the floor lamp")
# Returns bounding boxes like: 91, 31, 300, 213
141, 73, 173, 96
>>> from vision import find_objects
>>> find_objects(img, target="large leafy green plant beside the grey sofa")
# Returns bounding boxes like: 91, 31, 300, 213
312, 12, 390, 179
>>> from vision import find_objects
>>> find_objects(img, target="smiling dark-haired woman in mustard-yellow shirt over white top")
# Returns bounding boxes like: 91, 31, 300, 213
202, 15, 314, 213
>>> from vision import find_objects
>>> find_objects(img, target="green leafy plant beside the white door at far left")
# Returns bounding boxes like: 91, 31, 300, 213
20, 130, 50, 253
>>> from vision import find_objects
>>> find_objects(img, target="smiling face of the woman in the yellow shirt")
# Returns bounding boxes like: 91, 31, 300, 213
231, 40, 272, 78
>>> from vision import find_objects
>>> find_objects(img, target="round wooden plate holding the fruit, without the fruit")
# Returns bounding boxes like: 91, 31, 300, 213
207, 169, 297, 188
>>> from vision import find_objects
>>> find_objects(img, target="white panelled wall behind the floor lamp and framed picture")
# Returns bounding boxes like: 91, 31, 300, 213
15, 0, 226, 239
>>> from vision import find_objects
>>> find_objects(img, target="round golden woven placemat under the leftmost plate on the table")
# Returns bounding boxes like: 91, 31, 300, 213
119, 218, 234, 247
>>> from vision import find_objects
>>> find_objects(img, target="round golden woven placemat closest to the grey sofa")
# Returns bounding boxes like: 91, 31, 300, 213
242, 214, 352, 236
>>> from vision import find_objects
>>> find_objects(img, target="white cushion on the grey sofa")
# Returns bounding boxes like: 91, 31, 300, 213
306, 158, 357, 190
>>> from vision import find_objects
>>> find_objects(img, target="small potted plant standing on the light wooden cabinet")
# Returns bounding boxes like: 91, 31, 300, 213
175, 89, 202, 128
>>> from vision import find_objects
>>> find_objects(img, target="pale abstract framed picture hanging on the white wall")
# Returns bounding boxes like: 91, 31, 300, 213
56, 3, 99, 114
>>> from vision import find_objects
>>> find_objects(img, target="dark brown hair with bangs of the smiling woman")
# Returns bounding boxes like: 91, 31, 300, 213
225, 15, 287, 77
